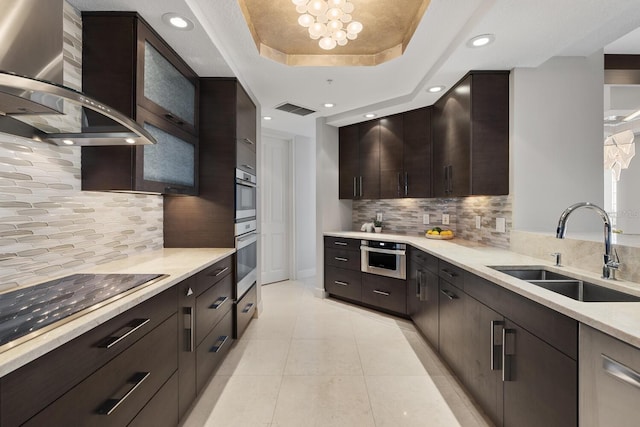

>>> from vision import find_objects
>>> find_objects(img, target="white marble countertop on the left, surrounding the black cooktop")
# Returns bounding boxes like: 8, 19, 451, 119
0, 248, 235, 377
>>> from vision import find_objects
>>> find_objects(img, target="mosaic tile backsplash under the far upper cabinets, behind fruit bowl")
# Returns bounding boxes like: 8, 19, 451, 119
352, 196, 512, 248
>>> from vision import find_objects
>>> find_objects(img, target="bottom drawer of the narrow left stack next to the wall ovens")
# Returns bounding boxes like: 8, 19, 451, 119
196, 311, 233, 393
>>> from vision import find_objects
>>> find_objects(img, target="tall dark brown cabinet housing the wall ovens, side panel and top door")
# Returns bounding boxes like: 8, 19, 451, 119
163, 77, 256, 248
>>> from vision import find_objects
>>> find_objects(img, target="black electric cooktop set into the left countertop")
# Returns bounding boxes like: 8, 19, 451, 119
0, 274, 166, 352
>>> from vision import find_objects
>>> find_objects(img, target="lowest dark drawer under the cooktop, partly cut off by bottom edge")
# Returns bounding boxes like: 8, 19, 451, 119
128, 372, 179, 427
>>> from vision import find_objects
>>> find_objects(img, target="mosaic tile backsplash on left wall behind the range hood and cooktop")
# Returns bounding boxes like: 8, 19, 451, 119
0, 3, 163, 291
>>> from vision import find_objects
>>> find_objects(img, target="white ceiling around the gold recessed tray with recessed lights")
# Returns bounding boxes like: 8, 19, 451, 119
68, 0, 640, 136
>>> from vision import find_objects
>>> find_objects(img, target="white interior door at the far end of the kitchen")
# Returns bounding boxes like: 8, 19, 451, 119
260, 136, 291, 285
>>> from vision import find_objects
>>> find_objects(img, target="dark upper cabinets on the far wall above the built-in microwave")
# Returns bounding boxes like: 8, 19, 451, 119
339, 107, 431, 199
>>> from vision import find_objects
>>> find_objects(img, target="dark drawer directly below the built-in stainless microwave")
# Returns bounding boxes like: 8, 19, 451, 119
362, 273, 407, 314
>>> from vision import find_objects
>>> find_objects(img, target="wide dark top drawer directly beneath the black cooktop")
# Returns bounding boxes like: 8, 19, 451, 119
0, 286, 177, 426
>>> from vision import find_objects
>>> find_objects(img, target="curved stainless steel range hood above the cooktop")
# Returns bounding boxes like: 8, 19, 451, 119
0, 0, 156, 145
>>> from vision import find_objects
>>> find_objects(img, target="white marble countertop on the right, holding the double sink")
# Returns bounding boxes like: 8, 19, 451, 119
324, 231, 640, 348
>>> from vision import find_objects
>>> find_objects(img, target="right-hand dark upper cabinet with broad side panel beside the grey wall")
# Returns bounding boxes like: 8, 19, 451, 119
432, 71, 509, 197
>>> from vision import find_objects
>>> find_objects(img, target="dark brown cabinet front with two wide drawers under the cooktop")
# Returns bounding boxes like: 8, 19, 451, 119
0, 287, 178, 427
